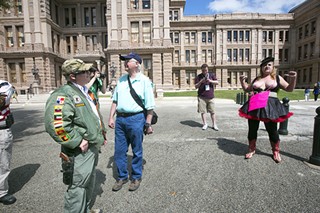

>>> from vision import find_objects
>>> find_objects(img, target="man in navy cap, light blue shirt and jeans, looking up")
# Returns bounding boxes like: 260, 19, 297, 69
108, 52, 155, 191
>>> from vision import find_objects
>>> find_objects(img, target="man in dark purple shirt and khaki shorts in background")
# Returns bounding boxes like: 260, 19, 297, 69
195, 64, 219, 131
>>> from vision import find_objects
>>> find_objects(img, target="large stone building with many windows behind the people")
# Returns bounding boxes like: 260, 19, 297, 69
0, 0, 320, 94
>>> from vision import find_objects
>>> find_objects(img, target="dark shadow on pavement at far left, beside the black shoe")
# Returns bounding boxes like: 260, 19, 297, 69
8, 163, 40, 194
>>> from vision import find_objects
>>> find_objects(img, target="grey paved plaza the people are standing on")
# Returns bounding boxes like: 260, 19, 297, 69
0, 96, 320, 213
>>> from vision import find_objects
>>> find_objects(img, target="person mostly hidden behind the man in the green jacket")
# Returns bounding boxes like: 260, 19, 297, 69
86, 67, 107, 106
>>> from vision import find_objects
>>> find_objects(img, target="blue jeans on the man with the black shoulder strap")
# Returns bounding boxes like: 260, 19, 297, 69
114, 113, 146, 180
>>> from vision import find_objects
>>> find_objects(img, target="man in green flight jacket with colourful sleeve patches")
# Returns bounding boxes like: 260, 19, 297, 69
45, 59, 107, 213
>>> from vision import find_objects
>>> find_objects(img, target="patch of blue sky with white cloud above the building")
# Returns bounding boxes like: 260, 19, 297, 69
185, 0, 306, 15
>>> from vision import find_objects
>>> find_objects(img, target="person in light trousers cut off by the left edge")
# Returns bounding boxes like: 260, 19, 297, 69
0, 80, 17, 205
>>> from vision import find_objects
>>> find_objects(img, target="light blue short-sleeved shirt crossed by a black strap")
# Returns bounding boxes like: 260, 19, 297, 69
112, 73, 155, 113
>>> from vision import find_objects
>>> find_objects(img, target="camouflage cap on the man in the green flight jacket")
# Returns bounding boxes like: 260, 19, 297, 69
62, 59, 93, 75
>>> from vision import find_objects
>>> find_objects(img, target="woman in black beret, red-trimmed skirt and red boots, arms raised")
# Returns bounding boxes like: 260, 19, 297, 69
239, 57, 297, 163
